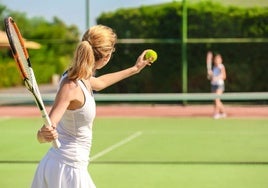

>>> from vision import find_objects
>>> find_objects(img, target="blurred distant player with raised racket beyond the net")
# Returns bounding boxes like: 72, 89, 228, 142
207, 51, 226, 119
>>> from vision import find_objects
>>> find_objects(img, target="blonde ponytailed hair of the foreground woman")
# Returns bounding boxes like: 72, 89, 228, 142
68, 25, 117, 80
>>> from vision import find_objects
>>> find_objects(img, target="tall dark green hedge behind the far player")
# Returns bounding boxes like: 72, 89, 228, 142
97, 1, 268, 93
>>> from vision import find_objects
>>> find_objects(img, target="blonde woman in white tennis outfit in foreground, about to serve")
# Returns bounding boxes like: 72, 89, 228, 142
32, 25, 153, 188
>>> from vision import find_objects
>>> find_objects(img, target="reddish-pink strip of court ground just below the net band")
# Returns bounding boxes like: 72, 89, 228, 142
0, 104, 268, 117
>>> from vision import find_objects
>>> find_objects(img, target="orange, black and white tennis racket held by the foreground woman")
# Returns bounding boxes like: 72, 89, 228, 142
5, 17, 60, 148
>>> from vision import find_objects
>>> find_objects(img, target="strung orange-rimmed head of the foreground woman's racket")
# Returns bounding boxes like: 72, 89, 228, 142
5, 17, 34, 87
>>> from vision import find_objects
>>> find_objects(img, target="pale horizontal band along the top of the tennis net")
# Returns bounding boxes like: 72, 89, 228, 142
0, 92, 268, 105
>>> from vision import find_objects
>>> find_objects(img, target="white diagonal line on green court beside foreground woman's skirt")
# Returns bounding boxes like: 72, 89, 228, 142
90, 131, 142, 161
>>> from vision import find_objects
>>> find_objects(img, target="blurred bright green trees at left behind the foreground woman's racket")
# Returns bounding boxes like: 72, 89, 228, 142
0, 5, 80, 87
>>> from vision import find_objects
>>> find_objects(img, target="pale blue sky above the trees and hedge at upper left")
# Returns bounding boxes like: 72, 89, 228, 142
0, 0, 174, 32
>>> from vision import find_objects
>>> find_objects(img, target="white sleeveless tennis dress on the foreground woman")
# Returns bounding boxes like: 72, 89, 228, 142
32, 76, 96, 188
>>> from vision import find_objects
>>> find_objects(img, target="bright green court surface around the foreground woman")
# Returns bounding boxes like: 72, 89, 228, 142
0, 117, 268, 188
